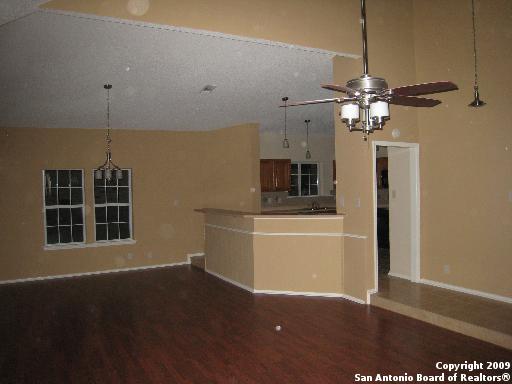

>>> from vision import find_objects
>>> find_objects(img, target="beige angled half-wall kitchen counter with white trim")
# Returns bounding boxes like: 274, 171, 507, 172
198, 208, 352, 297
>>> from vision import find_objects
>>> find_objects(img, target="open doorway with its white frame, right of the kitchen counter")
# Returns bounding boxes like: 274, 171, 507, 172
373, 141, 420, 291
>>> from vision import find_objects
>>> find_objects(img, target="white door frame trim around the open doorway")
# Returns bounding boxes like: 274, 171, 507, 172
372, 141, 420, 292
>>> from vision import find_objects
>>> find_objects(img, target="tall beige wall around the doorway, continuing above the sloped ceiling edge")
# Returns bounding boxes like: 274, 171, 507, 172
34, 0, 512, 297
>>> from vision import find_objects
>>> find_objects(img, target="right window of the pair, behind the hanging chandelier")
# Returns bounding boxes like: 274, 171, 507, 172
93, 169, 132, 241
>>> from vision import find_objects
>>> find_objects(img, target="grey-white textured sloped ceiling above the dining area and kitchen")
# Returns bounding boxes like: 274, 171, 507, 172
0, 11, 344, 132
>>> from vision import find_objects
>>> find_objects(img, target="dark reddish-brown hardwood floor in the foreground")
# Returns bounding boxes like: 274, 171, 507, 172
0, 266, 512, 383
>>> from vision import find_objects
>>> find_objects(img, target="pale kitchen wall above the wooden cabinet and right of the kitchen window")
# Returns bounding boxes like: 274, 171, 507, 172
260, 131, 334, 195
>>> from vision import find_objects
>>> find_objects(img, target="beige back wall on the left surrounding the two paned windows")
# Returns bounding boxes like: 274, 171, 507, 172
0, 125, 260, 280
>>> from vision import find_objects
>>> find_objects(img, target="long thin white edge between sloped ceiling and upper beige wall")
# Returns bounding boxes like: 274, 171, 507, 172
36, 8, 361, 59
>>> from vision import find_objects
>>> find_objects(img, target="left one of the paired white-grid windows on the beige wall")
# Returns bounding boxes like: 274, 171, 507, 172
43, 169, 85, 245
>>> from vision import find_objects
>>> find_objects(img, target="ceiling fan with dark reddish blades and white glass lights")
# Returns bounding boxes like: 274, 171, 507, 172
281, 0, 458, 140
